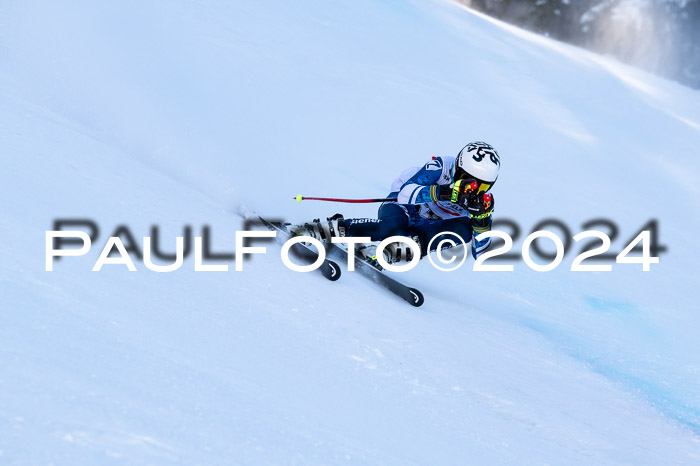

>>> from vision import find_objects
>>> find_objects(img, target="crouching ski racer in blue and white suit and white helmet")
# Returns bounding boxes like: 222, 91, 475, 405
295, 142, 501, 264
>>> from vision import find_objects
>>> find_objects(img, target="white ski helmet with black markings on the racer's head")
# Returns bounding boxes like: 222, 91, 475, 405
452, 142, 501, 192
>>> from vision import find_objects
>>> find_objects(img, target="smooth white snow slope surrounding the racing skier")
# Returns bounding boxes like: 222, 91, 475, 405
0, 0, 700, 464
